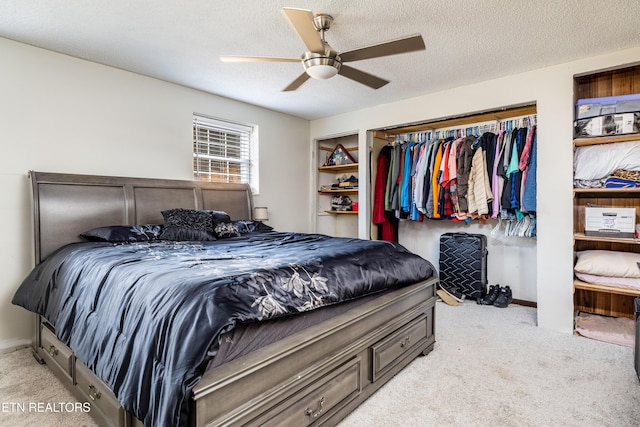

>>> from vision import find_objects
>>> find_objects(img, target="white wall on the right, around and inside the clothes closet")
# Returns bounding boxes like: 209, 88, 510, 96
311, 47, 640, 333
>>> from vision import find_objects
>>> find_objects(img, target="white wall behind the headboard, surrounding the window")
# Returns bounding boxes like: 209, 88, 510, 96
0, 38, 311, 352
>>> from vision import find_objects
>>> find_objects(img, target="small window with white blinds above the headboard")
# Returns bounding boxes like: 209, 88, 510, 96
193, 115, 257, 192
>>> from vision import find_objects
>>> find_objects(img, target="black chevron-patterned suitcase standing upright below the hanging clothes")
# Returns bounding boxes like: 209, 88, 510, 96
439, 233, 488, 300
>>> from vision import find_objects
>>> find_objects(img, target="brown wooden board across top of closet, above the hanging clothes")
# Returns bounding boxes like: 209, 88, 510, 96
380, 104, 537, 135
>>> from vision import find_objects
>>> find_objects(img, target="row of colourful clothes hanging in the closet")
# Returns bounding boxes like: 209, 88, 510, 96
374, 114, 537, 235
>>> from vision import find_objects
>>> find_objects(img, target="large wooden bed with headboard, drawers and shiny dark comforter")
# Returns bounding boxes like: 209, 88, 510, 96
14, 171, 437, 426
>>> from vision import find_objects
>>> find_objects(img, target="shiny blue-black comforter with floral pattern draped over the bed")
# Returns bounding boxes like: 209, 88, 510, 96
13, 232, 435, 426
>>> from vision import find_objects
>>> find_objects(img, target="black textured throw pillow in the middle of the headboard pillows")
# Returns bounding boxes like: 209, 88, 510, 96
160, 208, 215, 241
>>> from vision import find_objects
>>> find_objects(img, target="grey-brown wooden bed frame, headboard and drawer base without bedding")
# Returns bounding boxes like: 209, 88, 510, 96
29, 171, 437, 426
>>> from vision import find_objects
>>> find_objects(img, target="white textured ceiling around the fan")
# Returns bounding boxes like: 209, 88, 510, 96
0, 0, 640, 119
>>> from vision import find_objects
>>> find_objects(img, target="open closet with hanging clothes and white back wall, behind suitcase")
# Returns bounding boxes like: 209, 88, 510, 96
370, 103, 537, 307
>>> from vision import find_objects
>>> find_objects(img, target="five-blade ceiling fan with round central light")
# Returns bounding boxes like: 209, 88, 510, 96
220, 7, 425, 91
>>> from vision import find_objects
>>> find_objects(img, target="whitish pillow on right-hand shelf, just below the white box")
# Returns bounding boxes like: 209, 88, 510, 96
574, 250, 640, 277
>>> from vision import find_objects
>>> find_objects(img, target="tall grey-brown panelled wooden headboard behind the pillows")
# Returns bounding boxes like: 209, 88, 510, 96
29, 171, 253, 263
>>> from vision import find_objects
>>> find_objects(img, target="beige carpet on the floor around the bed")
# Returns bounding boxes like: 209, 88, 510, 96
0, 302, 640, 427
